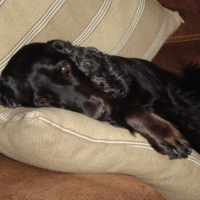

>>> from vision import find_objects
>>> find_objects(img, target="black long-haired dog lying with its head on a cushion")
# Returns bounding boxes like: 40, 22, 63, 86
0, 40, 200, 159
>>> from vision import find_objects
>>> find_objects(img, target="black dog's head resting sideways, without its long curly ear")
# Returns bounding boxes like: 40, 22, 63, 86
0, 41, 117, 120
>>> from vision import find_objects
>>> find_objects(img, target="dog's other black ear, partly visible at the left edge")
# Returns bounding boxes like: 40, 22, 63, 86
0, 77, 20, 108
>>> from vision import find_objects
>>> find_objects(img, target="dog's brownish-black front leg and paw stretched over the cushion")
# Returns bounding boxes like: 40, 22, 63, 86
122, 103, 191, 159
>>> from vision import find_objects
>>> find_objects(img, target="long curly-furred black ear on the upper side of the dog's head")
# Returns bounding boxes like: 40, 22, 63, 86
48, 41, 131, 98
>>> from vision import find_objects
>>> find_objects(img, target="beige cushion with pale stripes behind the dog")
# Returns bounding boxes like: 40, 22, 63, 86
0, 0, 181, 71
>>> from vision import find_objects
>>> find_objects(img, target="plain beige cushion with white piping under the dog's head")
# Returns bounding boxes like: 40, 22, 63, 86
0, 107, 200, 200
